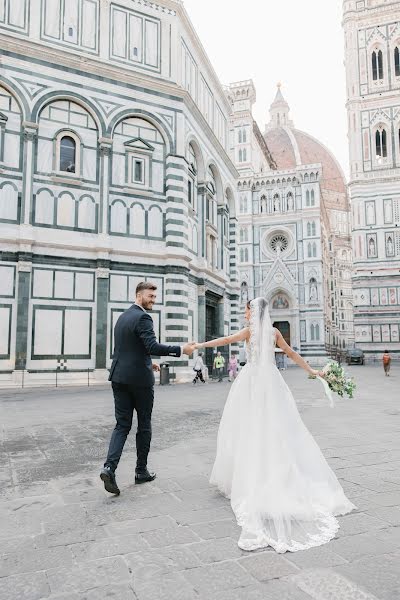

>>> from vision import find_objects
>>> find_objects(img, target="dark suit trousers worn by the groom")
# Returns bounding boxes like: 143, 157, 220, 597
104, 381, 154, 472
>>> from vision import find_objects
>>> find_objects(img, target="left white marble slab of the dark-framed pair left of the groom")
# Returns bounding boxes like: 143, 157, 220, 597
33, 308, 62, 356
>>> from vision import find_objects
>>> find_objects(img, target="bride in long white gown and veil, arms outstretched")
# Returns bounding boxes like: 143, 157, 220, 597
196, 298, 356, 552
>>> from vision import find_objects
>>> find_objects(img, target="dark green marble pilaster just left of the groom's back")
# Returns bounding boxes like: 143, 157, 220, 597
95, 260, 110, 370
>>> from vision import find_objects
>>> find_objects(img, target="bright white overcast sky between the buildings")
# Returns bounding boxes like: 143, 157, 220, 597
184, 0, 348, 175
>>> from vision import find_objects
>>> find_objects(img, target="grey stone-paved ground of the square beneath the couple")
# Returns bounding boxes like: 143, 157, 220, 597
0, 367, 400, 600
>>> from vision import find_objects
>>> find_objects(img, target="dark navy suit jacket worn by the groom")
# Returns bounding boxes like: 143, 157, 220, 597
108, 304, 181, 387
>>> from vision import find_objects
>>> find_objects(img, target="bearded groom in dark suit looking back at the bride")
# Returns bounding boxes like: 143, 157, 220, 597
100, 281, 195, 494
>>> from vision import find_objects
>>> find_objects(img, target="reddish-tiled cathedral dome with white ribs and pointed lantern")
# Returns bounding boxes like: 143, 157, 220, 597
264, 86, 346, 194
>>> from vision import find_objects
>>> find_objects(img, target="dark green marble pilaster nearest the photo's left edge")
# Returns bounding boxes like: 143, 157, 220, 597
15, 253, 32, 370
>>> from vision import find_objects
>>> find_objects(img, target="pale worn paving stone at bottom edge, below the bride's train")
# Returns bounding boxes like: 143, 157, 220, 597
291, 567, 378, 600
